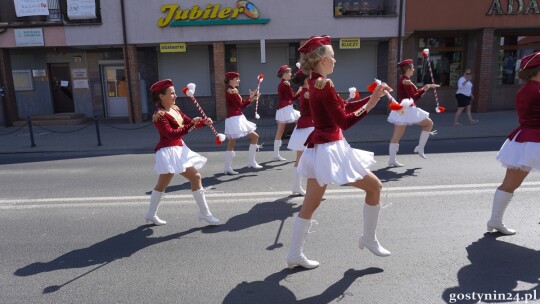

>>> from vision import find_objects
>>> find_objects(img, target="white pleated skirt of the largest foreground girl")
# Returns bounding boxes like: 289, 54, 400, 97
297, 139, 375, 187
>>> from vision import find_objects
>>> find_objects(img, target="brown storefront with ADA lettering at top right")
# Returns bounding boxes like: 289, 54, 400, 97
404, 0, 540, 112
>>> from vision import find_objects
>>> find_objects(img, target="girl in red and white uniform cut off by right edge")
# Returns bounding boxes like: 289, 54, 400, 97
487, 52, 540, 234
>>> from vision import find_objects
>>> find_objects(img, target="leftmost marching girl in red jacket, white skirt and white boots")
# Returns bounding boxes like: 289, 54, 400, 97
144, 79, 219, 225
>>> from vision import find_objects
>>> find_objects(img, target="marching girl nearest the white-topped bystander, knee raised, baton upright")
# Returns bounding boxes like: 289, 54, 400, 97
388, 59, 440, 167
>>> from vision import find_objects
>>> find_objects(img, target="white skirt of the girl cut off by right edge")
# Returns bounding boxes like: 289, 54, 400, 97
497, 133, 540, 172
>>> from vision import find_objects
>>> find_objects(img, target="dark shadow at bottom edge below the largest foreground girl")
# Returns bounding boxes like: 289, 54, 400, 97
223, 267, 383, 304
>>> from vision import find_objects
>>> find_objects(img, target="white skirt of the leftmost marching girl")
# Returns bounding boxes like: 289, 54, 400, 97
154, 143, 207, 174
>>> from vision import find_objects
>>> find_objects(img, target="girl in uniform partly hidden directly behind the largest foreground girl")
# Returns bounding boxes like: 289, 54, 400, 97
287, 70, 314, 195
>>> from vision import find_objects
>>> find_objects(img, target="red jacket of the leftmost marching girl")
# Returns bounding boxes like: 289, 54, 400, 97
152, 105, 205, 151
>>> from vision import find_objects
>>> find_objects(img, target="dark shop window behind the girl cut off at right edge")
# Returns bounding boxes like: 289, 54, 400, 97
497, 35, 540, 85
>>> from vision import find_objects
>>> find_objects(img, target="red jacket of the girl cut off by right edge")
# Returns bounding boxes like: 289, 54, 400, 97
508, 80, 540, 142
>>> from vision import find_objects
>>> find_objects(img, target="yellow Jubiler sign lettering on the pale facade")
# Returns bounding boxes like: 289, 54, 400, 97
157, 0, 270, 27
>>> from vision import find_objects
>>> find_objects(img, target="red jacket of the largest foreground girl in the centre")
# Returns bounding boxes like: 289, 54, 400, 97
306, 72, 369, 147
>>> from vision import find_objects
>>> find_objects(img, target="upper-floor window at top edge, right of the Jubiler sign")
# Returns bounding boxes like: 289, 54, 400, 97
334, 0, 397, 17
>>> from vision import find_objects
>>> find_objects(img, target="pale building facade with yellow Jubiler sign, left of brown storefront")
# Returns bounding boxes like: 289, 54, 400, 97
0, 0, 399, 126
